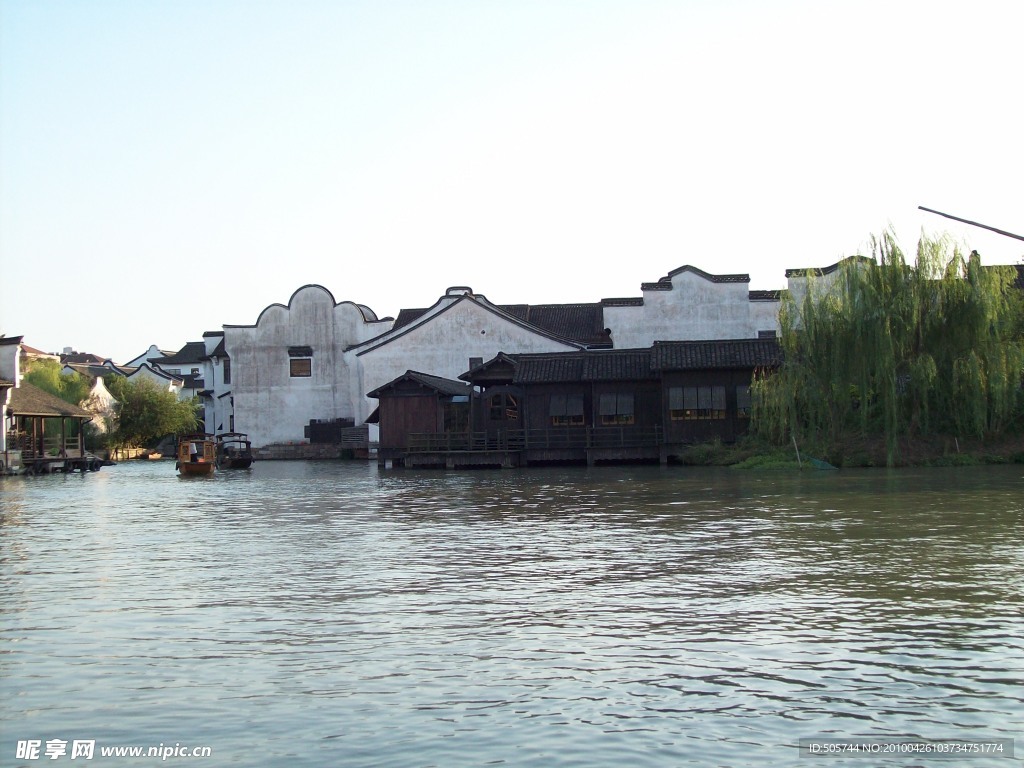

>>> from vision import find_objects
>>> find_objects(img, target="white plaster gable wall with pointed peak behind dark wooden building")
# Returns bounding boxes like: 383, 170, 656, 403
349, 300, 577, 420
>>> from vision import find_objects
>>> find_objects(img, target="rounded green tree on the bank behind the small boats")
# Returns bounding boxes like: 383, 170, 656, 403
108, 377, 199, 446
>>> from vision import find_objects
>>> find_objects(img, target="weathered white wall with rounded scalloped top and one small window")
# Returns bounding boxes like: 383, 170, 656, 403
224, 286, 390, 446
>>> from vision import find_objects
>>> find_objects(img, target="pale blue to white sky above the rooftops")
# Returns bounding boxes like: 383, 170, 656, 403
0, 0, 1024, 362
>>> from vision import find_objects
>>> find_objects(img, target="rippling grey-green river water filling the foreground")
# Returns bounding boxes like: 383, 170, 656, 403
0, 462, 1024, 768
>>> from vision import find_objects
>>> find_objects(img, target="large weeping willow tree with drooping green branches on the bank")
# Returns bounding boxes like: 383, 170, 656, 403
753, 231, 1024, 466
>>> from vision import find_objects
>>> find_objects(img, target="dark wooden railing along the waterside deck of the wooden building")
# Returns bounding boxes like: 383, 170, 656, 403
408, 426, 664, 453
